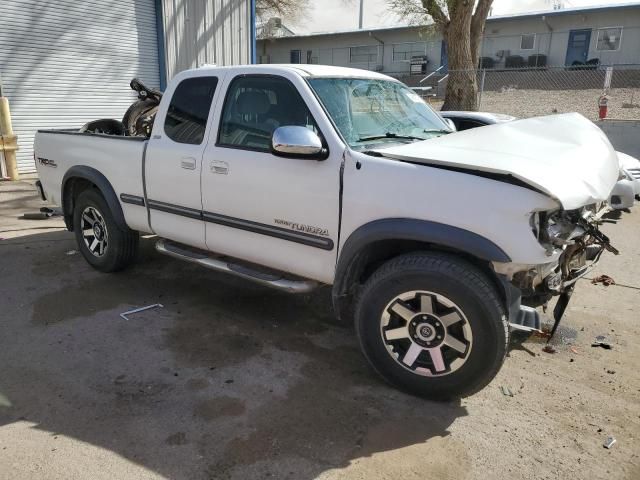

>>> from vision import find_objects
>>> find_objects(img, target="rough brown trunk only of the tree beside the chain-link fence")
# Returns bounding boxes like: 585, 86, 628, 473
442, 6, 478, 110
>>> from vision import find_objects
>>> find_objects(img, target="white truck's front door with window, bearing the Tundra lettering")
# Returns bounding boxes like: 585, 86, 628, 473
202, 72, 343, 282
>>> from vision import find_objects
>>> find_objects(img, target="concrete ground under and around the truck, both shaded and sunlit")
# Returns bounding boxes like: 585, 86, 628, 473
0, 182, 640, 480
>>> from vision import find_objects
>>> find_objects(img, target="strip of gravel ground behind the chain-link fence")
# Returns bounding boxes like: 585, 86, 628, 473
432, 88, 640, 120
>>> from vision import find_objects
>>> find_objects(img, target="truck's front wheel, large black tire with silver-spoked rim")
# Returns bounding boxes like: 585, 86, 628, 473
355, 252, 509, 400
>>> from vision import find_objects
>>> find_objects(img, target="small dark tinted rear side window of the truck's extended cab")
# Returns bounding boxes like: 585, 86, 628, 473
164, 77, 218, 145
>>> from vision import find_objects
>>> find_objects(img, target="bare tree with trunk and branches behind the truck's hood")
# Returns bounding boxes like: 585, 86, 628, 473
387, 0, 493, 110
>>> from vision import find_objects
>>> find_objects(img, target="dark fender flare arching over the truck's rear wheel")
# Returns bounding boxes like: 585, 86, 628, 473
60, 165, 129, 231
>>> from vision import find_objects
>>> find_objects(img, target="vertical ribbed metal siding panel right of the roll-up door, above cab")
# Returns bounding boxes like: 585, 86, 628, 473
162, 0, 254, 79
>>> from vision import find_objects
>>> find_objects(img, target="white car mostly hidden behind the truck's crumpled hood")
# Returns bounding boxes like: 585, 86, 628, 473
439, 110, 640, 210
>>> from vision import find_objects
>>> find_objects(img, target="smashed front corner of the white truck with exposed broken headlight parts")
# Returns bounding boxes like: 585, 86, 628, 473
524, 205, 619, 297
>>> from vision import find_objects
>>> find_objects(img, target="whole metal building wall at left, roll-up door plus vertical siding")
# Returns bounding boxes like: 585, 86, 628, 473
0, 0, 254, 173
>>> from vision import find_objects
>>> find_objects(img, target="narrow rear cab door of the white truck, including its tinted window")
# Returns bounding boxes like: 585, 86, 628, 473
145, 74, 224, 248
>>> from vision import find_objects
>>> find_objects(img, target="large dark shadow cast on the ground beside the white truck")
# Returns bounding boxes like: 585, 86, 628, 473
0, 232, 466, 480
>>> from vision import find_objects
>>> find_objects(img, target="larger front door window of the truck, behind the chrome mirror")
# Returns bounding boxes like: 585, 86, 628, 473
218, 76, 320, 152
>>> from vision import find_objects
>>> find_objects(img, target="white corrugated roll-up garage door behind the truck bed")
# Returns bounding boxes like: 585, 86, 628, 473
0, 0, 160, 173
